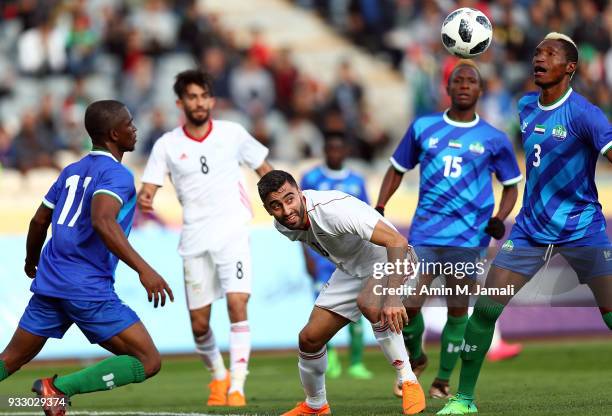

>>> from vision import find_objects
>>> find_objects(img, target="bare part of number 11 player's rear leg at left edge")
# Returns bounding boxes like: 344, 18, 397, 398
0, 327, 47, 381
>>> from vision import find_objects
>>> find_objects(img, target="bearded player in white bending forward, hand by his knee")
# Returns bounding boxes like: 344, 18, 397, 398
257, 170, 425, 416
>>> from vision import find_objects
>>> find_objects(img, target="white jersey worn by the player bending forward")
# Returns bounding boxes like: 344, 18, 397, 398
274, 190, 395, 278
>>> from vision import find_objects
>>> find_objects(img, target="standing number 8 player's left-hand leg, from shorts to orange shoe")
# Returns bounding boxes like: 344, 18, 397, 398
183, 253, 229, 406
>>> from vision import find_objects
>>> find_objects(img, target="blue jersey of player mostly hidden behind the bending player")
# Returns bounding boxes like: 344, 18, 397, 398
300, 166, 370, 282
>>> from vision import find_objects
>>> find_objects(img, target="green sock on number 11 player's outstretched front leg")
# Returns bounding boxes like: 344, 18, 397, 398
53, 355, 146, 396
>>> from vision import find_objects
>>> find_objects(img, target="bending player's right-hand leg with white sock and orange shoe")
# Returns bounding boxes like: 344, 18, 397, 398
357, 278, 425, 414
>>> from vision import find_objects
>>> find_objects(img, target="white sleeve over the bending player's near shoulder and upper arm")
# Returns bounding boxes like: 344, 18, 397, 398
319, 195, 383, 241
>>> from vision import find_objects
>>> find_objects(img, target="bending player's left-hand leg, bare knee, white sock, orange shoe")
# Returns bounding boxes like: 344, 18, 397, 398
283, 306, 350, 416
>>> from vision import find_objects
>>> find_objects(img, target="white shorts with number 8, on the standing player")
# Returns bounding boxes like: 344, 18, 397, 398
183, 232, 251, 310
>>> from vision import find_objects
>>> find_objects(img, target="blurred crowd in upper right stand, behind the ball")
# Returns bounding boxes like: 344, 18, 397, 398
294, 0, 612, 141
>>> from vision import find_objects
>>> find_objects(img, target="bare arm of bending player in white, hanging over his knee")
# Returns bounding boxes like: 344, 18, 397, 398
370, 220, 410, 334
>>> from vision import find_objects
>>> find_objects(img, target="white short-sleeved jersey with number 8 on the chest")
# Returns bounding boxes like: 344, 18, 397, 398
142, 120, 268, 256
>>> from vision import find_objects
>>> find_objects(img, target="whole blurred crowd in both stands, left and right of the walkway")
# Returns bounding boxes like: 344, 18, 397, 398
0, 0, 612, 173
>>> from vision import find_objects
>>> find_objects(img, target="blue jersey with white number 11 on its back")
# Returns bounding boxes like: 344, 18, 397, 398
31, 151, 136, 300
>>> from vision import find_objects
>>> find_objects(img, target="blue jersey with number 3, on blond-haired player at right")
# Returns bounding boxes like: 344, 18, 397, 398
516, 88, 612, 244
